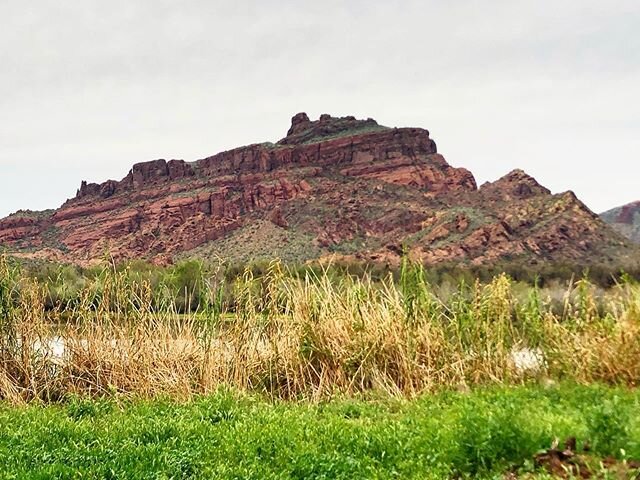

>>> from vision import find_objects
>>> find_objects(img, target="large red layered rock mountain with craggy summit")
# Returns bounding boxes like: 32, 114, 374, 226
0, 113, 637, 265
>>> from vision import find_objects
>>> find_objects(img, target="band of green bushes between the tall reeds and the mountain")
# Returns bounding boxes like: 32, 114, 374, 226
8, 253, 640, 316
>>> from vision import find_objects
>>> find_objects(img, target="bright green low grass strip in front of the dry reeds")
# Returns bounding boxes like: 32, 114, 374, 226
0, 384, 640, 479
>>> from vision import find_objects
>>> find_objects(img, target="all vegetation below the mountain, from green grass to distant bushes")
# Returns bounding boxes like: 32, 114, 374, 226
0, 257, 640, 479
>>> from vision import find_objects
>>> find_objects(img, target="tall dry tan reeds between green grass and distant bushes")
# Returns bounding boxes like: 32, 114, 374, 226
0, 257, 640, 403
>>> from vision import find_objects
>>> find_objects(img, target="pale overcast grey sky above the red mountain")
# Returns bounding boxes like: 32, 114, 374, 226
0, 0, 640, 217
